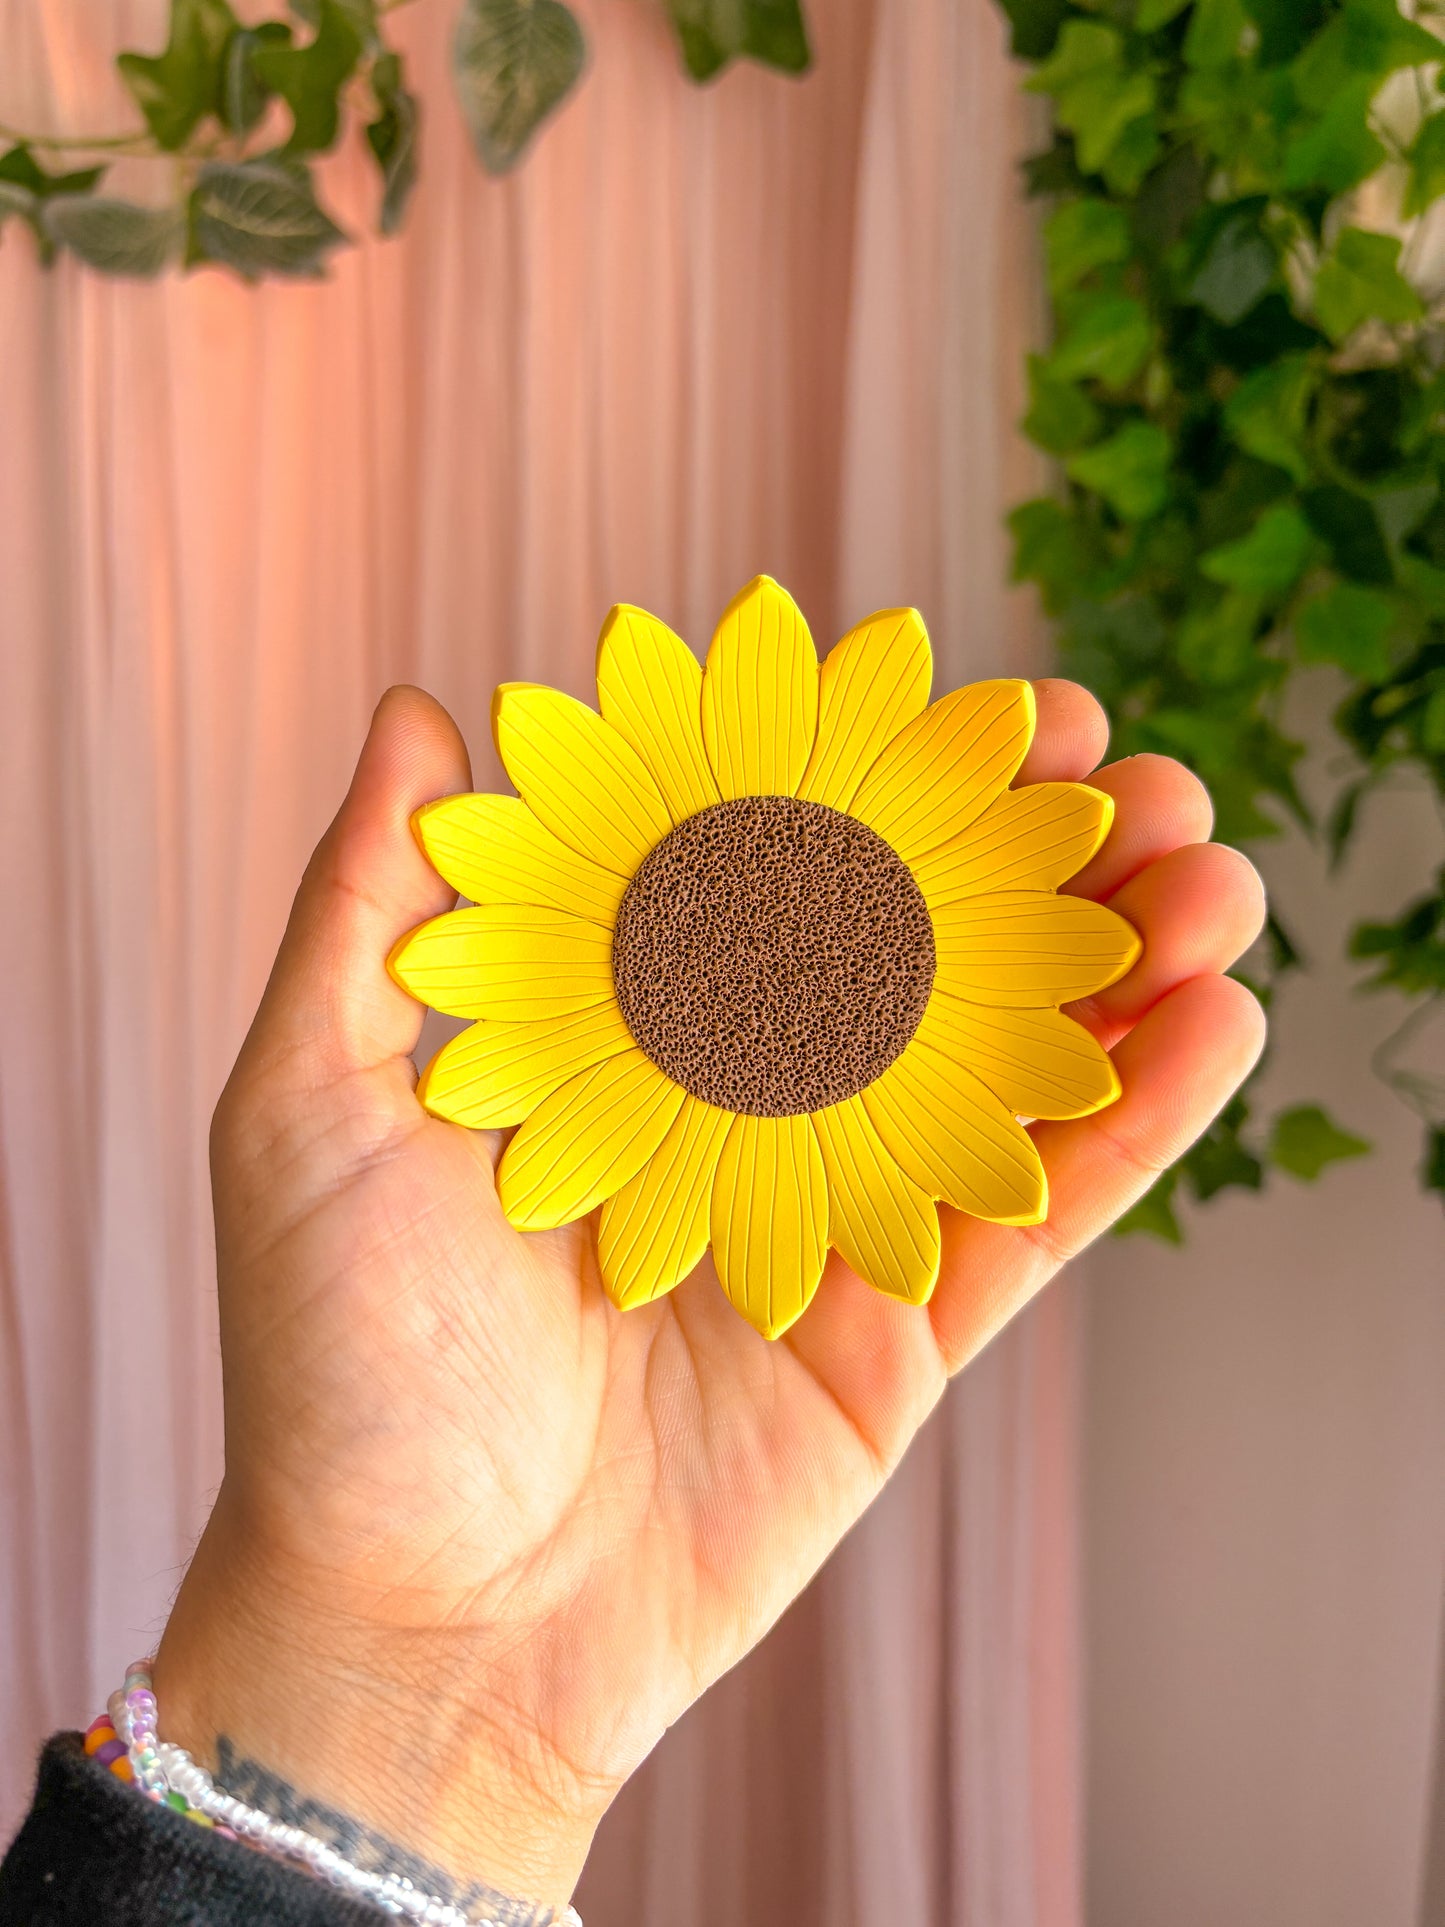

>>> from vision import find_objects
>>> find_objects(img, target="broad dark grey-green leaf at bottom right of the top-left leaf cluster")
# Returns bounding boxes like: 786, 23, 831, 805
191, 160, 347, 281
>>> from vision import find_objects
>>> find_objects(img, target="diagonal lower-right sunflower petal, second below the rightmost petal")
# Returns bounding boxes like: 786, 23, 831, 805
863, 1037, 1048, 1224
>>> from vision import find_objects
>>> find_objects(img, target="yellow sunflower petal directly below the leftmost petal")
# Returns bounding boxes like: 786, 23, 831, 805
416, 998, 632, 1131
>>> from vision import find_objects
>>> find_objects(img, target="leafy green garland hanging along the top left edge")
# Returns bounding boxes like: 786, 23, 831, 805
0, 0, 809, 281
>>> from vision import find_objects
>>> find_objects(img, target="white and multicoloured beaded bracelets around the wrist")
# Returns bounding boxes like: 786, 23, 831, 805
96, 1659, 582, 1927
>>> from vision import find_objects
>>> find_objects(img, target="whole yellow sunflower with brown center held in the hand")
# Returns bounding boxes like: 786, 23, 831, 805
389, 576, 1141, 1337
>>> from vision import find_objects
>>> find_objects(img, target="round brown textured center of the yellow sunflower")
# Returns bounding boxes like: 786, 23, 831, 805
613, 796, 934, 1118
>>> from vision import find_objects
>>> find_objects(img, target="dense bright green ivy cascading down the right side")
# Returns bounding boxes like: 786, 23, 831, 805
1002, 0, 1445, 1241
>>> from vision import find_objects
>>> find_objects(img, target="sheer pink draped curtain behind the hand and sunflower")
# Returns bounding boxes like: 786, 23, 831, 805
0, 0, 1079, 1927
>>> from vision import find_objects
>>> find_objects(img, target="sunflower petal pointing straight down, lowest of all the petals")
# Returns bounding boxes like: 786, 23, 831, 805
713, 1116, 828, 1337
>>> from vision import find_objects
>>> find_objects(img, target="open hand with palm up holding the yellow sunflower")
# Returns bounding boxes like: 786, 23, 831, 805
156, 682, 1264, 1902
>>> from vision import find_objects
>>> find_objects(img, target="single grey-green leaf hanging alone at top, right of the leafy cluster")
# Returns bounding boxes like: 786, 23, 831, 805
451, 0, 588, 173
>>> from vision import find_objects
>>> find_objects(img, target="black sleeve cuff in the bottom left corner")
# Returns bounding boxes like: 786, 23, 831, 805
0, 1732, 389, 1927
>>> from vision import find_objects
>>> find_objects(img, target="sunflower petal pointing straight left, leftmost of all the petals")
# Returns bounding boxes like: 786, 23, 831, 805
387, 904, 613, 1019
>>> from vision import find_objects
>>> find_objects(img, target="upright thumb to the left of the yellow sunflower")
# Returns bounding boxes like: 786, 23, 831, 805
237, 684, 472, 1087
